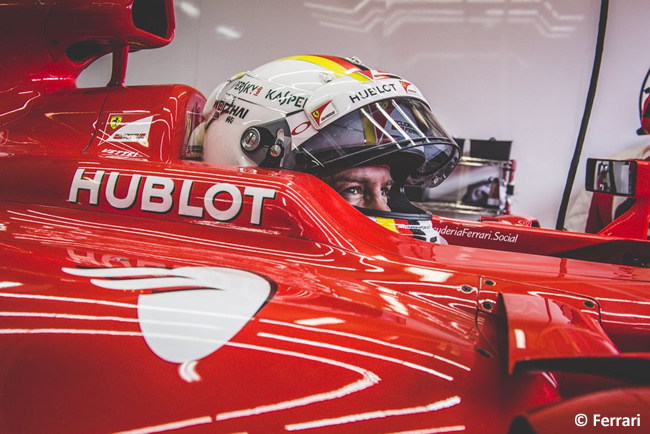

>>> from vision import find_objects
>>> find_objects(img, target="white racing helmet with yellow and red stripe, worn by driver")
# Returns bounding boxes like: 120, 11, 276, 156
203, 55, 460, 241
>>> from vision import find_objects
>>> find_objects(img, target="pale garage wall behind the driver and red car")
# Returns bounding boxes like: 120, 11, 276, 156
78, 0, 650, 230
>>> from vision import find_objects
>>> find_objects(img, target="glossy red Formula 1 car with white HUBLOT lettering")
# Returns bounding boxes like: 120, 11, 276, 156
0, 0, 650, 433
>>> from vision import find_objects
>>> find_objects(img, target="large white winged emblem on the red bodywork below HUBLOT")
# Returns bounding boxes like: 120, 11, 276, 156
63, 267, 272, 363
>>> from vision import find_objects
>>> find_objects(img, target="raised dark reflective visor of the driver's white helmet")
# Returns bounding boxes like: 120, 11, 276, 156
285, 98, 459, 186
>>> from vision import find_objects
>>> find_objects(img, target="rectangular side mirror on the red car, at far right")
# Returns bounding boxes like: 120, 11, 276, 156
585, 158, 637, 196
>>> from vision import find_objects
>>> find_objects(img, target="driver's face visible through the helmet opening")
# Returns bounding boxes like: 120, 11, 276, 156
323, 166, 393, 211
